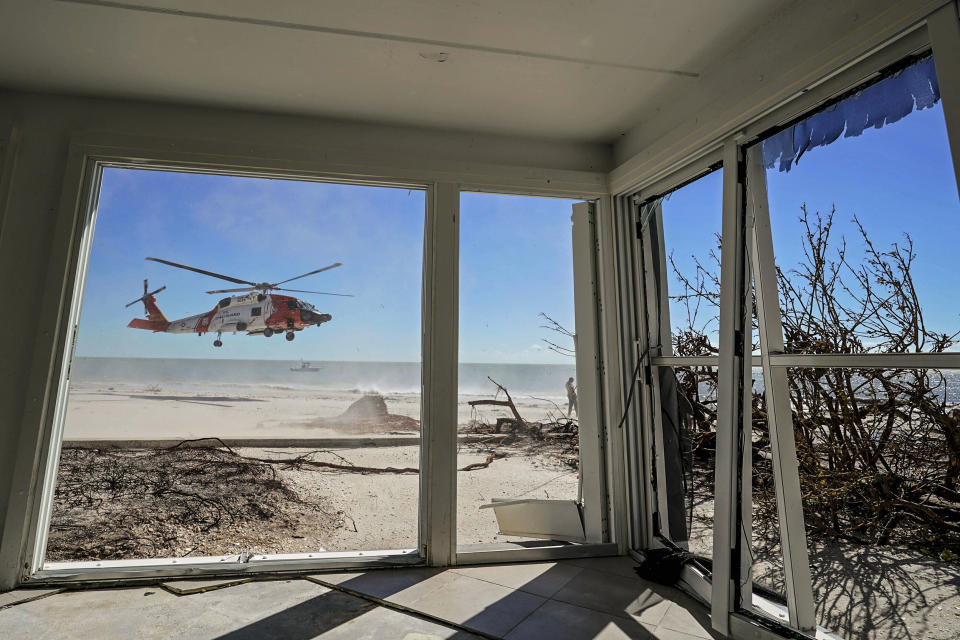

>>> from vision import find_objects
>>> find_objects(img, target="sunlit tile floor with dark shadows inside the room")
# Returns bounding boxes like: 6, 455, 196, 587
0, 558, 720, 640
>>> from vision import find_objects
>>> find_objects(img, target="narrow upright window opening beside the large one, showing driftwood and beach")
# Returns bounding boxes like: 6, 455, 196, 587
457, 193, 576, 548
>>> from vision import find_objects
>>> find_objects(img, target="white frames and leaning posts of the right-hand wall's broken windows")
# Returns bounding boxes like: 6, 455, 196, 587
613, 3, 960, 638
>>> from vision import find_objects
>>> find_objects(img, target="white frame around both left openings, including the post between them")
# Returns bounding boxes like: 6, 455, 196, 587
0, 134, 617, 584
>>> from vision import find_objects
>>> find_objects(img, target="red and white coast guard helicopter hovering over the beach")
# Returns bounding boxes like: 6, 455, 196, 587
126, 257, 353, 347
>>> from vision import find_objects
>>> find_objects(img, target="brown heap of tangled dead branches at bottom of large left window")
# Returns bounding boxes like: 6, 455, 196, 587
47, 447, 334, 560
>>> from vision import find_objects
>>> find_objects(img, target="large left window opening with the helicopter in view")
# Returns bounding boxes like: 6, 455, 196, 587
46, 168, 426, 566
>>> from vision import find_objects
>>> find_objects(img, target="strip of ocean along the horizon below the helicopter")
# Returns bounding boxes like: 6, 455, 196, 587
71, 357, 576, 398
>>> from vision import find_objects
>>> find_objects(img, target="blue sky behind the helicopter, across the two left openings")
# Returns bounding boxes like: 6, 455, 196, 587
77, 168, 573, 364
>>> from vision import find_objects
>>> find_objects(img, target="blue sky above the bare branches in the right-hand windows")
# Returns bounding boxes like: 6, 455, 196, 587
663, 94, 960, 348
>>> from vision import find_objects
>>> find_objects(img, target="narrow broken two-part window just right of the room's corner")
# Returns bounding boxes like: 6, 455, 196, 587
640, 171, 722, 559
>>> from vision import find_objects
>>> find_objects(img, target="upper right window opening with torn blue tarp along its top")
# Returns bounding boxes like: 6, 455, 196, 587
749, 53, 960, 353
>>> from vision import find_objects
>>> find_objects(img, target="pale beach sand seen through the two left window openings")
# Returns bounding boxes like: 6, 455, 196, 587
53, 385, 579, 559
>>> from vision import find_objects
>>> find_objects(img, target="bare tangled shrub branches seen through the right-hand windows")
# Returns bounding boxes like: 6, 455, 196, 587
671, 207, 960, 550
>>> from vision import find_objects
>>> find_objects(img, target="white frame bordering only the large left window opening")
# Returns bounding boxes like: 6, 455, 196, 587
21, 154, 435, 583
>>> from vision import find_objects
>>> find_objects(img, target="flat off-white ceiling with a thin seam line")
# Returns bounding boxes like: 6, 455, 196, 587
0, 0, 791, 143
